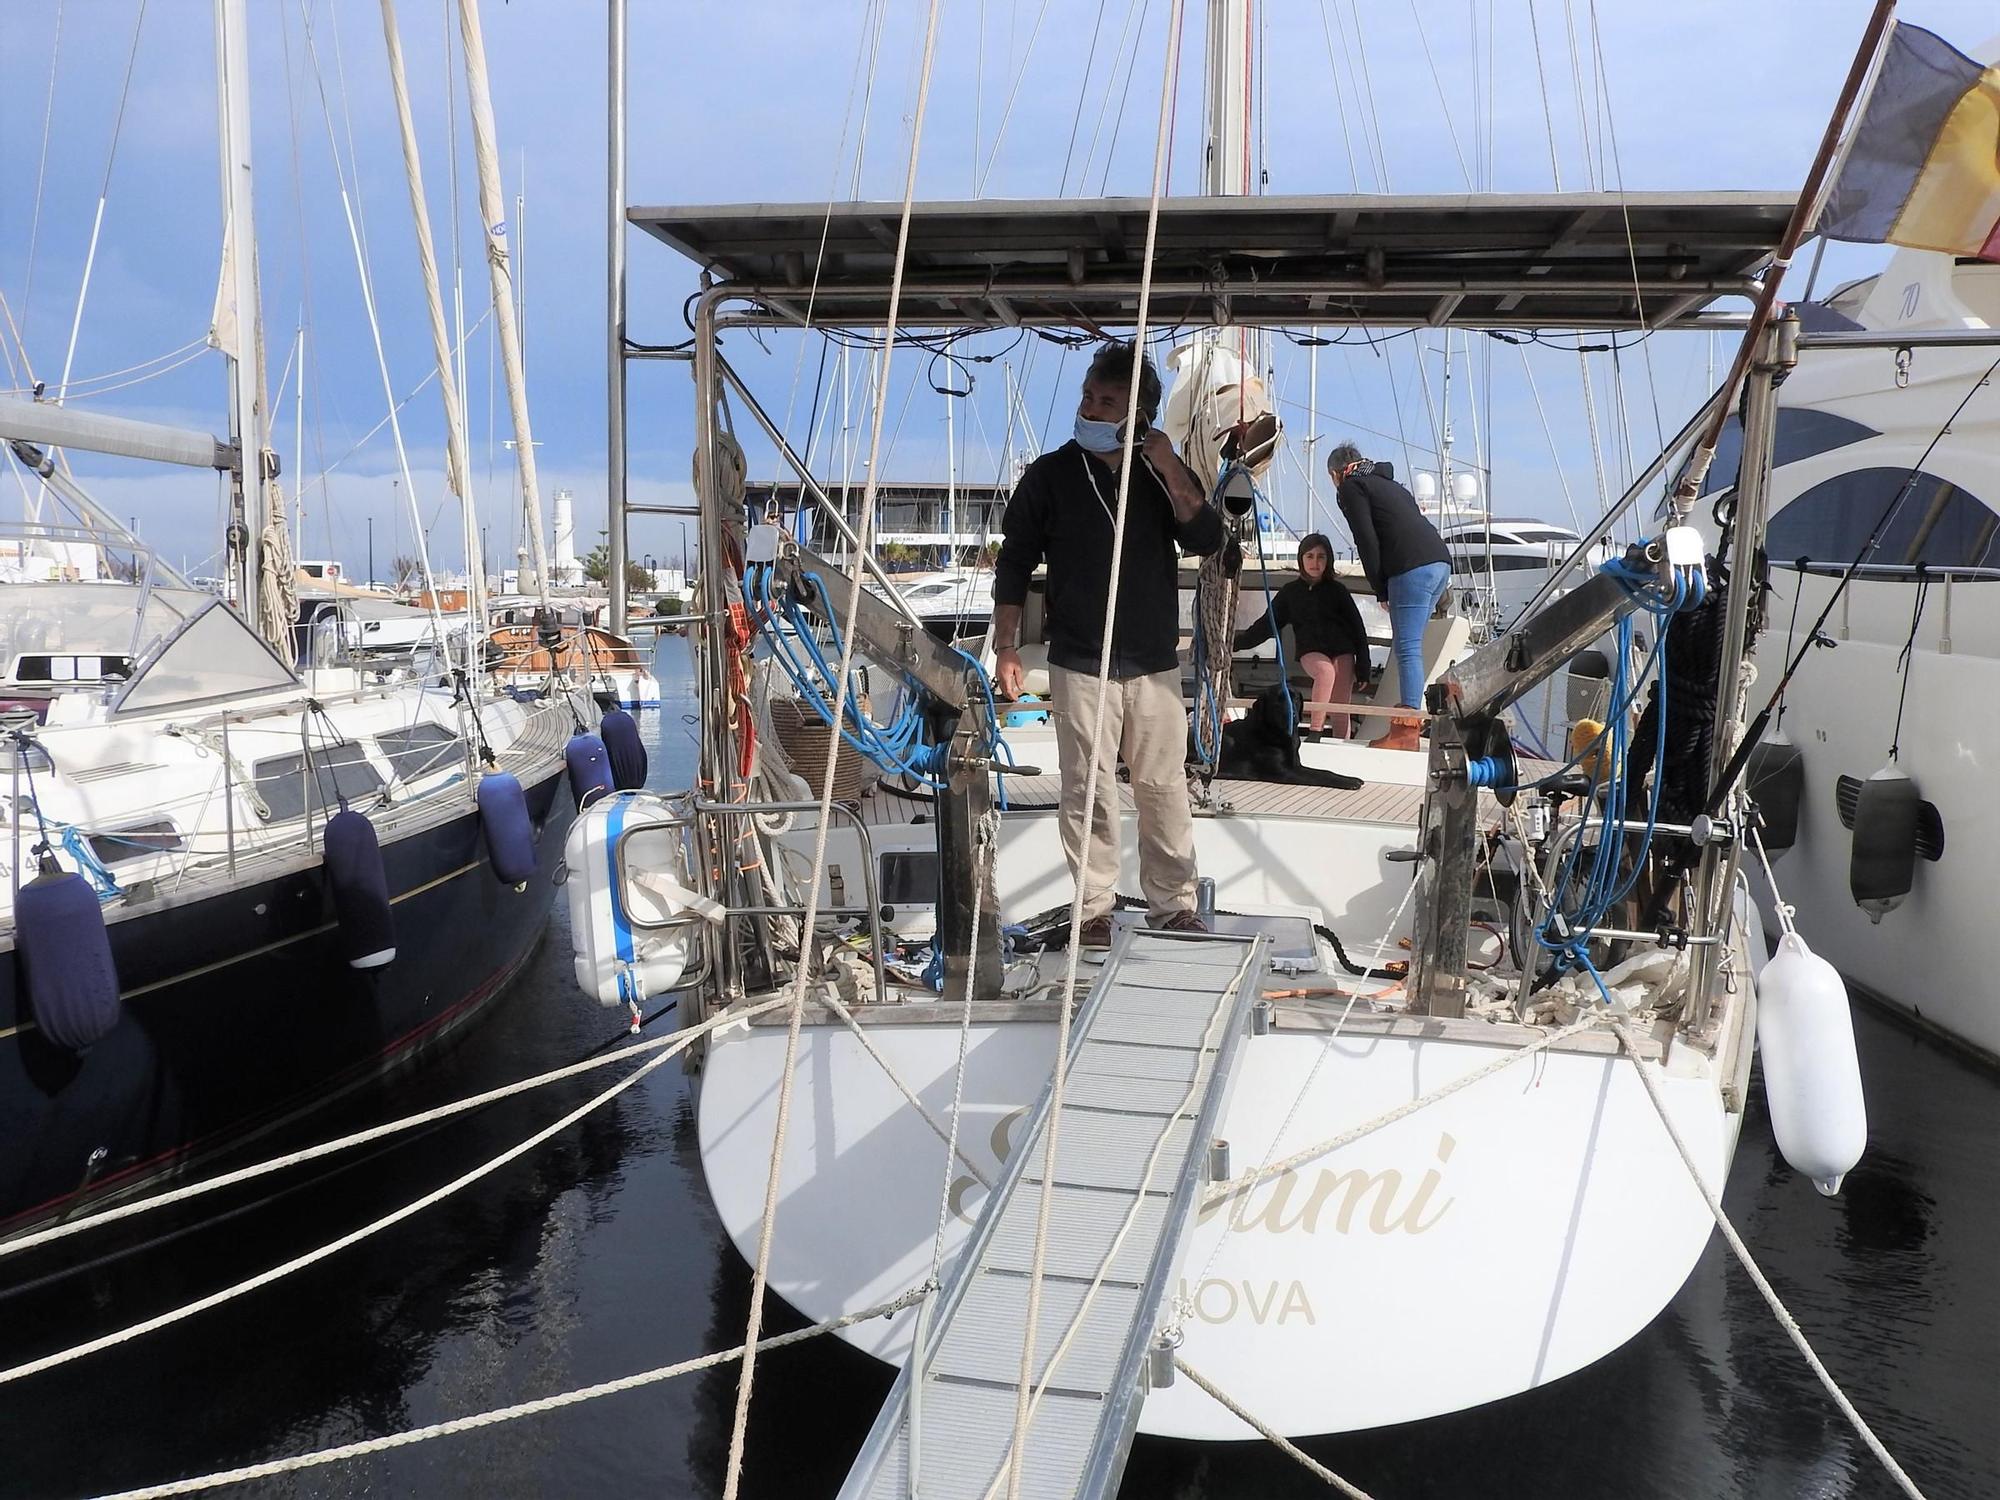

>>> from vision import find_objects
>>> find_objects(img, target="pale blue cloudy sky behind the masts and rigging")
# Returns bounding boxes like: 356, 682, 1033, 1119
0, 0, 1994, 570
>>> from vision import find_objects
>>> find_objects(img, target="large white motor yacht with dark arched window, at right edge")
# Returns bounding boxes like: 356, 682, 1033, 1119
1722, 250, 2000, 1056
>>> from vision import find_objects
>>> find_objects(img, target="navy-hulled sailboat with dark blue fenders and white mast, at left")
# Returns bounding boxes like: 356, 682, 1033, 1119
0, 0, 594, 1230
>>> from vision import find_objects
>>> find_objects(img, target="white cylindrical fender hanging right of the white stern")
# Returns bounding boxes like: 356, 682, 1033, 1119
1756, 932, 1868, 1196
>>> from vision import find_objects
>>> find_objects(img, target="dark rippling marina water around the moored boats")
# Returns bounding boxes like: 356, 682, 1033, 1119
0, 638, 2000, 1500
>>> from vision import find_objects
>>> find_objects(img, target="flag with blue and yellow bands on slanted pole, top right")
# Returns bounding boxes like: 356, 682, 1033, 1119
1818, 26, 2000, 260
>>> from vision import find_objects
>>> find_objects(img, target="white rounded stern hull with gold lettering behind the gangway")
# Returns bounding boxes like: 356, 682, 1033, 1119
698, 1008, 1740, 1440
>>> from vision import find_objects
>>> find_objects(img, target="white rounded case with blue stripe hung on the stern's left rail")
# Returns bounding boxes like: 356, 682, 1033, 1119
564, 792, 722, 1006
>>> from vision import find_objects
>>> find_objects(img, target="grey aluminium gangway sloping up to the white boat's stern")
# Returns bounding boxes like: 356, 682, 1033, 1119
840, 928, 1270, 1500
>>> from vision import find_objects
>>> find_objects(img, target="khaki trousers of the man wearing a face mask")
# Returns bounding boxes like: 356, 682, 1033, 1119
1048, 666, 1194, 922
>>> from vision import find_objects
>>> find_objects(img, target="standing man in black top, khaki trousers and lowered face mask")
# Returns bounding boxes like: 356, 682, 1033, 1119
992, 344, 1222, 948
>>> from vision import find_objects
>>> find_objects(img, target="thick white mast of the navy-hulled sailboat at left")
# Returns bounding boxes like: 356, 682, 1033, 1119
210, 0, 266, 632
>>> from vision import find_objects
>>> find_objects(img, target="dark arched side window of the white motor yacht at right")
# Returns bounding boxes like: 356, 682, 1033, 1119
1766, 468, 2000, 578
